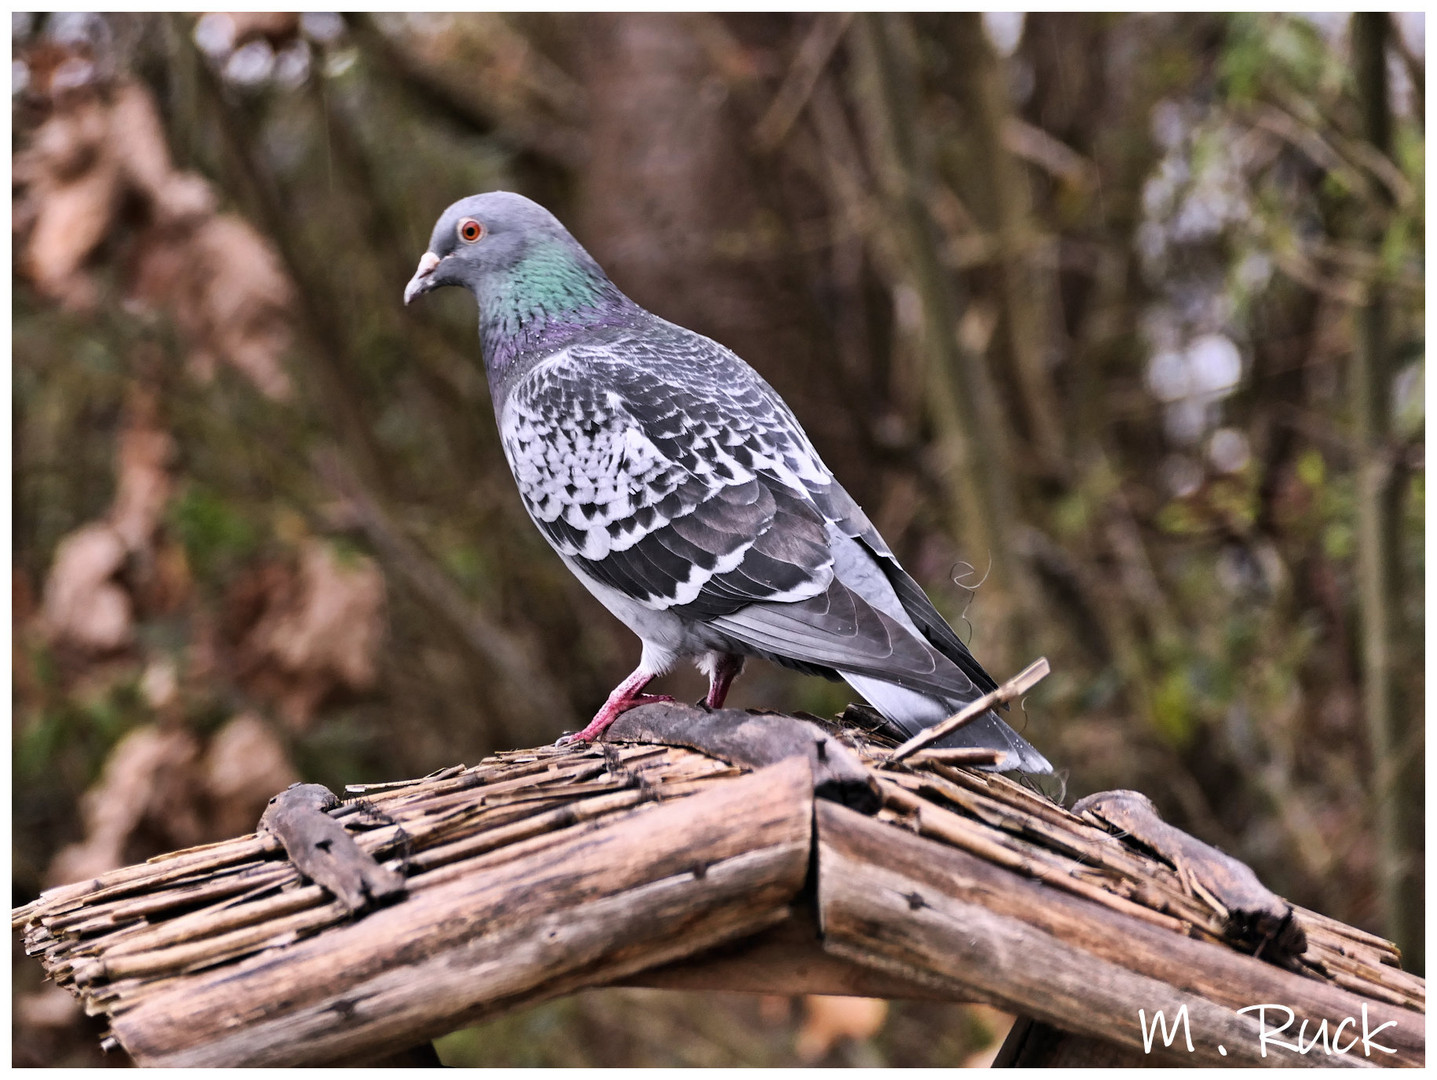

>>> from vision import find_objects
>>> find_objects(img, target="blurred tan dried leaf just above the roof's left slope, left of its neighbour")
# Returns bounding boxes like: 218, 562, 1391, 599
45, 725, 204, 885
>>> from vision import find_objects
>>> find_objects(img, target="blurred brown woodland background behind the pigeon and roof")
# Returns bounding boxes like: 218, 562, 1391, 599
11, 13, 1426, 1066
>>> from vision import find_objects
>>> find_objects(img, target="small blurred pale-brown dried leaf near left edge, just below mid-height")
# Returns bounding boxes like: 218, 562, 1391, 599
40, 521, 134, 653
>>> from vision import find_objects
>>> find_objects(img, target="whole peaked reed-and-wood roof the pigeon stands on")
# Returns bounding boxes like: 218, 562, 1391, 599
11, 705, 1426, 1066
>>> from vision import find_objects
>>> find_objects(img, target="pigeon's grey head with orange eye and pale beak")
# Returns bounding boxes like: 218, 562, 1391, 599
404, 191, 586, 303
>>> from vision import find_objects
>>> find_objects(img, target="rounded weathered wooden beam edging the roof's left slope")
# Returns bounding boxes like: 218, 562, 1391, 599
114, 761, 813, 1067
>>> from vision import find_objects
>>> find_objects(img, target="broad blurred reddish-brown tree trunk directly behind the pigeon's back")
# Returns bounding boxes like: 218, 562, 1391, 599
575, 13, 877, 501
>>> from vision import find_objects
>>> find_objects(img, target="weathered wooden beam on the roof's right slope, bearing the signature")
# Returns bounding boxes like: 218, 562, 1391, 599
815, 803, 1424, 1066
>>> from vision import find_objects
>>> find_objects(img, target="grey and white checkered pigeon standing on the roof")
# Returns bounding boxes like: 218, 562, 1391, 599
404, 191, 1052, 773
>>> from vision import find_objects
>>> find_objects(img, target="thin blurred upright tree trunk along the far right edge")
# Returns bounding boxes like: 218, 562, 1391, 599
1351, 11, 1424, 969
